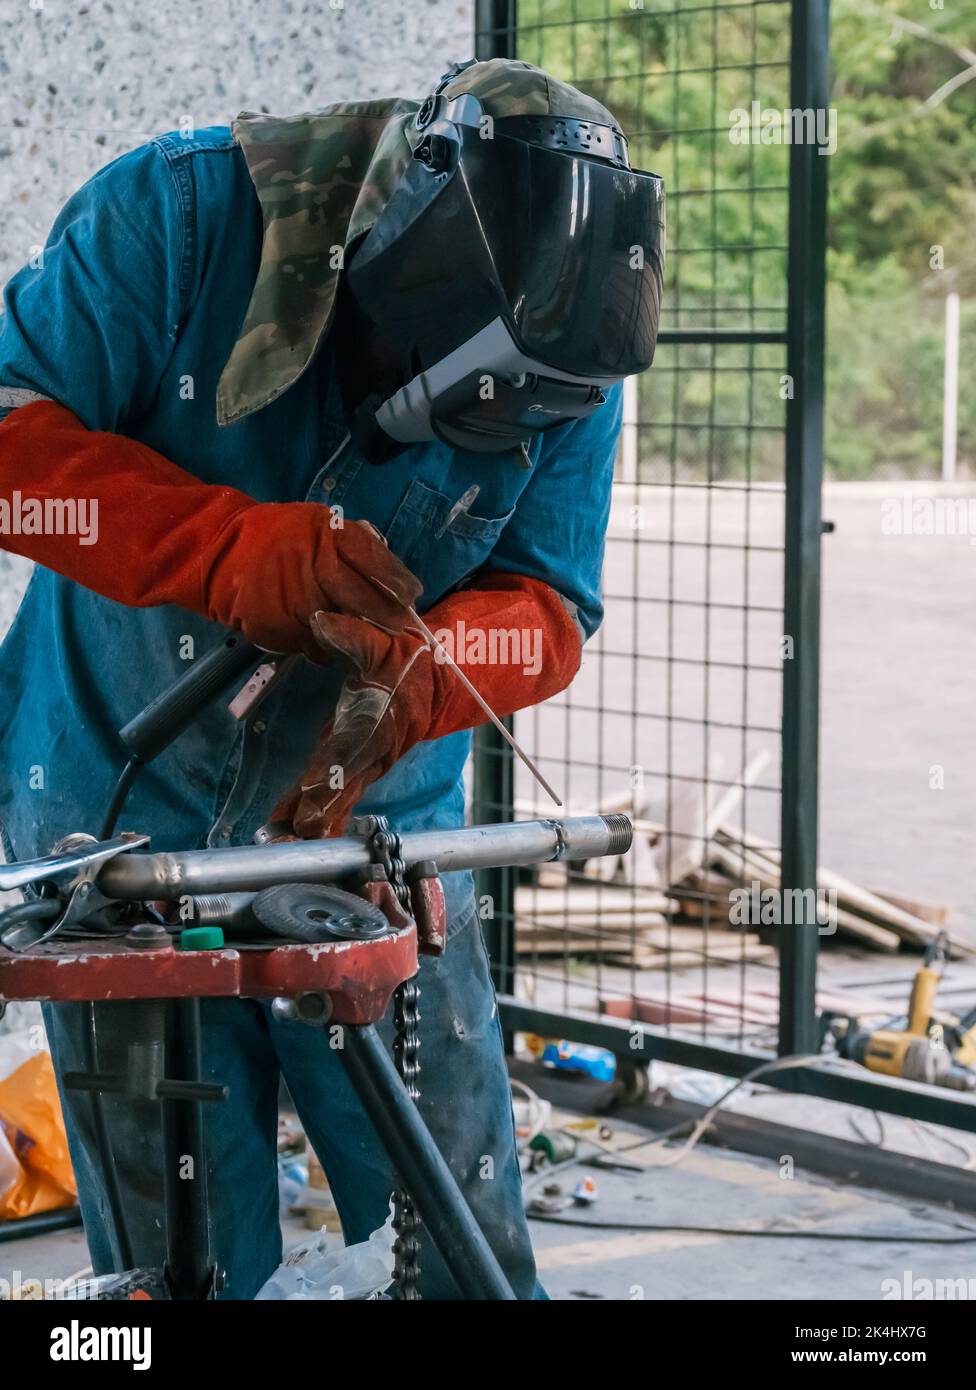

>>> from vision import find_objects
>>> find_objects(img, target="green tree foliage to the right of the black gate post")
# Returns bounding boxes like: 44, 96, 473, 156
827, 0, 976, 477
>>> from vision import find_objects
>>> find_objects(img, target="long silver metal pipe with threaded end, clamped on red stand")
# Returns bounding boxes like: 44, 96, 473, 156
97, 816, 634, 902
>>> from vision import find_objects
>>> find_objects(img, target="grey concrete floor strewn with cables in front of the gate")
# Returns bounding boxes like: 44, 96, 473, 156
7, 1095, 976, 1301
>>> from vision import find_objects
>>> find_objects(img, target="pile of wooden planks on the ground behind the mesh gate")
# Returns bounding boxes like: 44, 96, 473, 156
516, 752, 976, 970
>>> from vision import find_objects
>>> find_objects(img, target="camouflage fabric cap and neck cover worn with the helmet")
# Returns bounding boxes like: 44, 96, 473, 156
217, 58, 616, 425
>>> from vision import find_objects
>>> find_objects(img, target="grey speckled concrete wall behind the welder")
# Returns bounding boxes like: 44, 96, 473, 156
0, 0, 474, 632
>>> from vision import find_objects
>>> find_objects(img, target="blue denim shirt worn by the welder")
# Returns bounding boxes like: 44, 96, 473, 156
0, 128, 620, 920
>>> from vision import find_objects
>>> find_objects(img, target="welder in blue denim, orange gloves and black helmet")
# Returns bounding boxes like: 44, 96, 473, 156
0, 60, 663, 1298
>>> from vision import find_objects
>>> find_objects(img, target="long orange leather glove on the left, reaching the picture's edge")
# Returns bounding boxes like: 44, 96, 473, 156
0, 400, 421, 662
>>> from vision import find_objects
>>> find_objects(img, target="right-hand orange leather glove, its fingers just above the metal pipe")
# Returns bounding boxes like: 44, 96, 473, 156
271, 574, 580, 840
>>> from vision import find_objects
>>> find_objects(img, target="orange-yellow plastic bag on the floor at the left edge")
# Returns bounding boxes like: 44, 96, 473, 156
0, 1052, 78, 1220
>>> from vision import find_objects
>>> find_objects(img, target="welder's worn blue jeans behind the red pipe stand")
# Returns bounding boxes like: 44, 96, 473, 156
44, 916, 545, 1298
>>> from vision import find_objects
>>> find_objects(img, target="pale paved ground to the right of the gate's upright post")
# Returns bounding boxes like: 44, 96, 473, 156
820, 493, 976, 927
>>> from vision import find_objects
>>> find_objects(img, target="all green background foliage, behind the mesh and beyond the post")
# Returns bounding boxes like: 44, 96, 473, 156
519, 0, 976, 478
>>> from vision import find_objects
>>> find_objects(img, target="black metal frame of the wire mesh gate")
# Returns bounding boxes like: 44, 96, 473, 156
474, 0, 976, 1131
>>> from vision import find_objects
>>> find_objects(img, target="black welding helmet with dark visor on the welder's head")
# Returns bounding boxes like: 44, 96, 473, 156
345, 61, 665, 461
